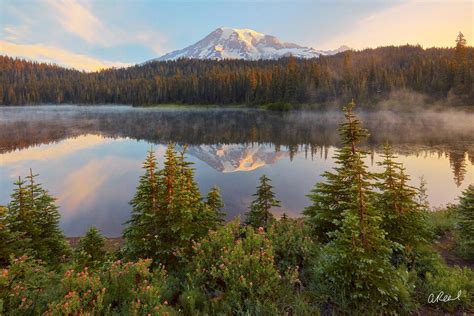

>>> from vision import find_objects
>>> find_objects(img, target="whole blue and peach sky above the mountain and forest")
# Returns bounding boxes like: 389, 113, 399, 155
0, 0, 474, 71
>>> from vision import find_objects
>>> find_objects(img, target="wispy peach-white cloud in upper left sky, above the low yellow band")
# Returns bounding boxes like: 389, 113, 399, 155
0, 0, 168, 59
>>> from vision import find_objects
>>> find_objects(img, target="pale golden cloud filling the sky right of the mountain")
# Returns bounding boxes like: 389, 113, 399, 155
321, 0, 474, 49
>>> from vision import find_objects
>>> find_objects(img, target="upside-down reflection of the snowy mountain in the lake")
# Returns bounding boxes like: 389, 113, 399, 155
188, 144, 289, 173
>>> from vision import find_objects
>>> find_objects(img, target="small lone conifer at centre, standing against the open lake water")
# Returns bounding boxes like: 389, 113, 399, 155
246, 175, 280, 229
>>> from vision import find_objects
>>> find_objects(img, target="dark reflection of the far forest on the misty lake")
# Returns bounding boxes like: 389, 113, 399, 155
0, 106, 474, 186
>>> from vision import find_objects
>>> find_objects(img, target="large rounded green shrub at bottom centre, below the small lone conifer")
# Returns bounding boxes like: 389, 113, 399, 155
180, 220, 309, 314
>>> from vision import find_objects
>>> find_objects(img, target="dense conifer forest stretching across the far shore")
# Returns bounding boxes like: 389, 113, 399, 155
0, 33, 474, 109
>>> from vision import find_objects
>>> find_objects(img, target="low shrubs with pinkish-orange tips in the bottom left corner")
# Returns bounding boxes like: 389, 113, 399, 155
0, 257, 175, 315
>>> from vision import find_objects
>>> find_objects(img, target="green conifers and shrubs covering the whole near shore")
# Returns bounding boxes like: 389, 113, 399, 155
0, 103, 474, 315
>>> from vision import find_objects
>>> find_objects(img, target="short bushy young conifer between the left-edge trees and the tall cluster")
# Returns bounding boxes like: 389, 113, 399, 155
75, 226, 106, 267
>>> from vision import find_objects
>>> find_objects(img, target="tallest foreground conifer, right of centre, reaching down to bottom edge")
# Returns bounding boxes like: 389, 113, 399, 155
309, 102, 406, 314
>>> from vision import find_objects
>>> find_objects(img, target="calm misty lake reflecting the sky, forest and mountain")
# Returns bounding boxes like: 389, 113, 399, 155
0, 105, 474, 236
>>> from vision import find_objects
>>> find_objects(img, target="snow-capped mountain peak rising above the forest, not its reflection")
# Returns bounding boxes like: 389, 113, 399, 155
155, 27, 350, 61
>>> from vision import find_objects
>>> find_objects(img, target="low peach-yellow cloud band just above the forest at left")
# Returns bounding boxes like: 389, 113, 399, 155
0, 40, 131, 71
